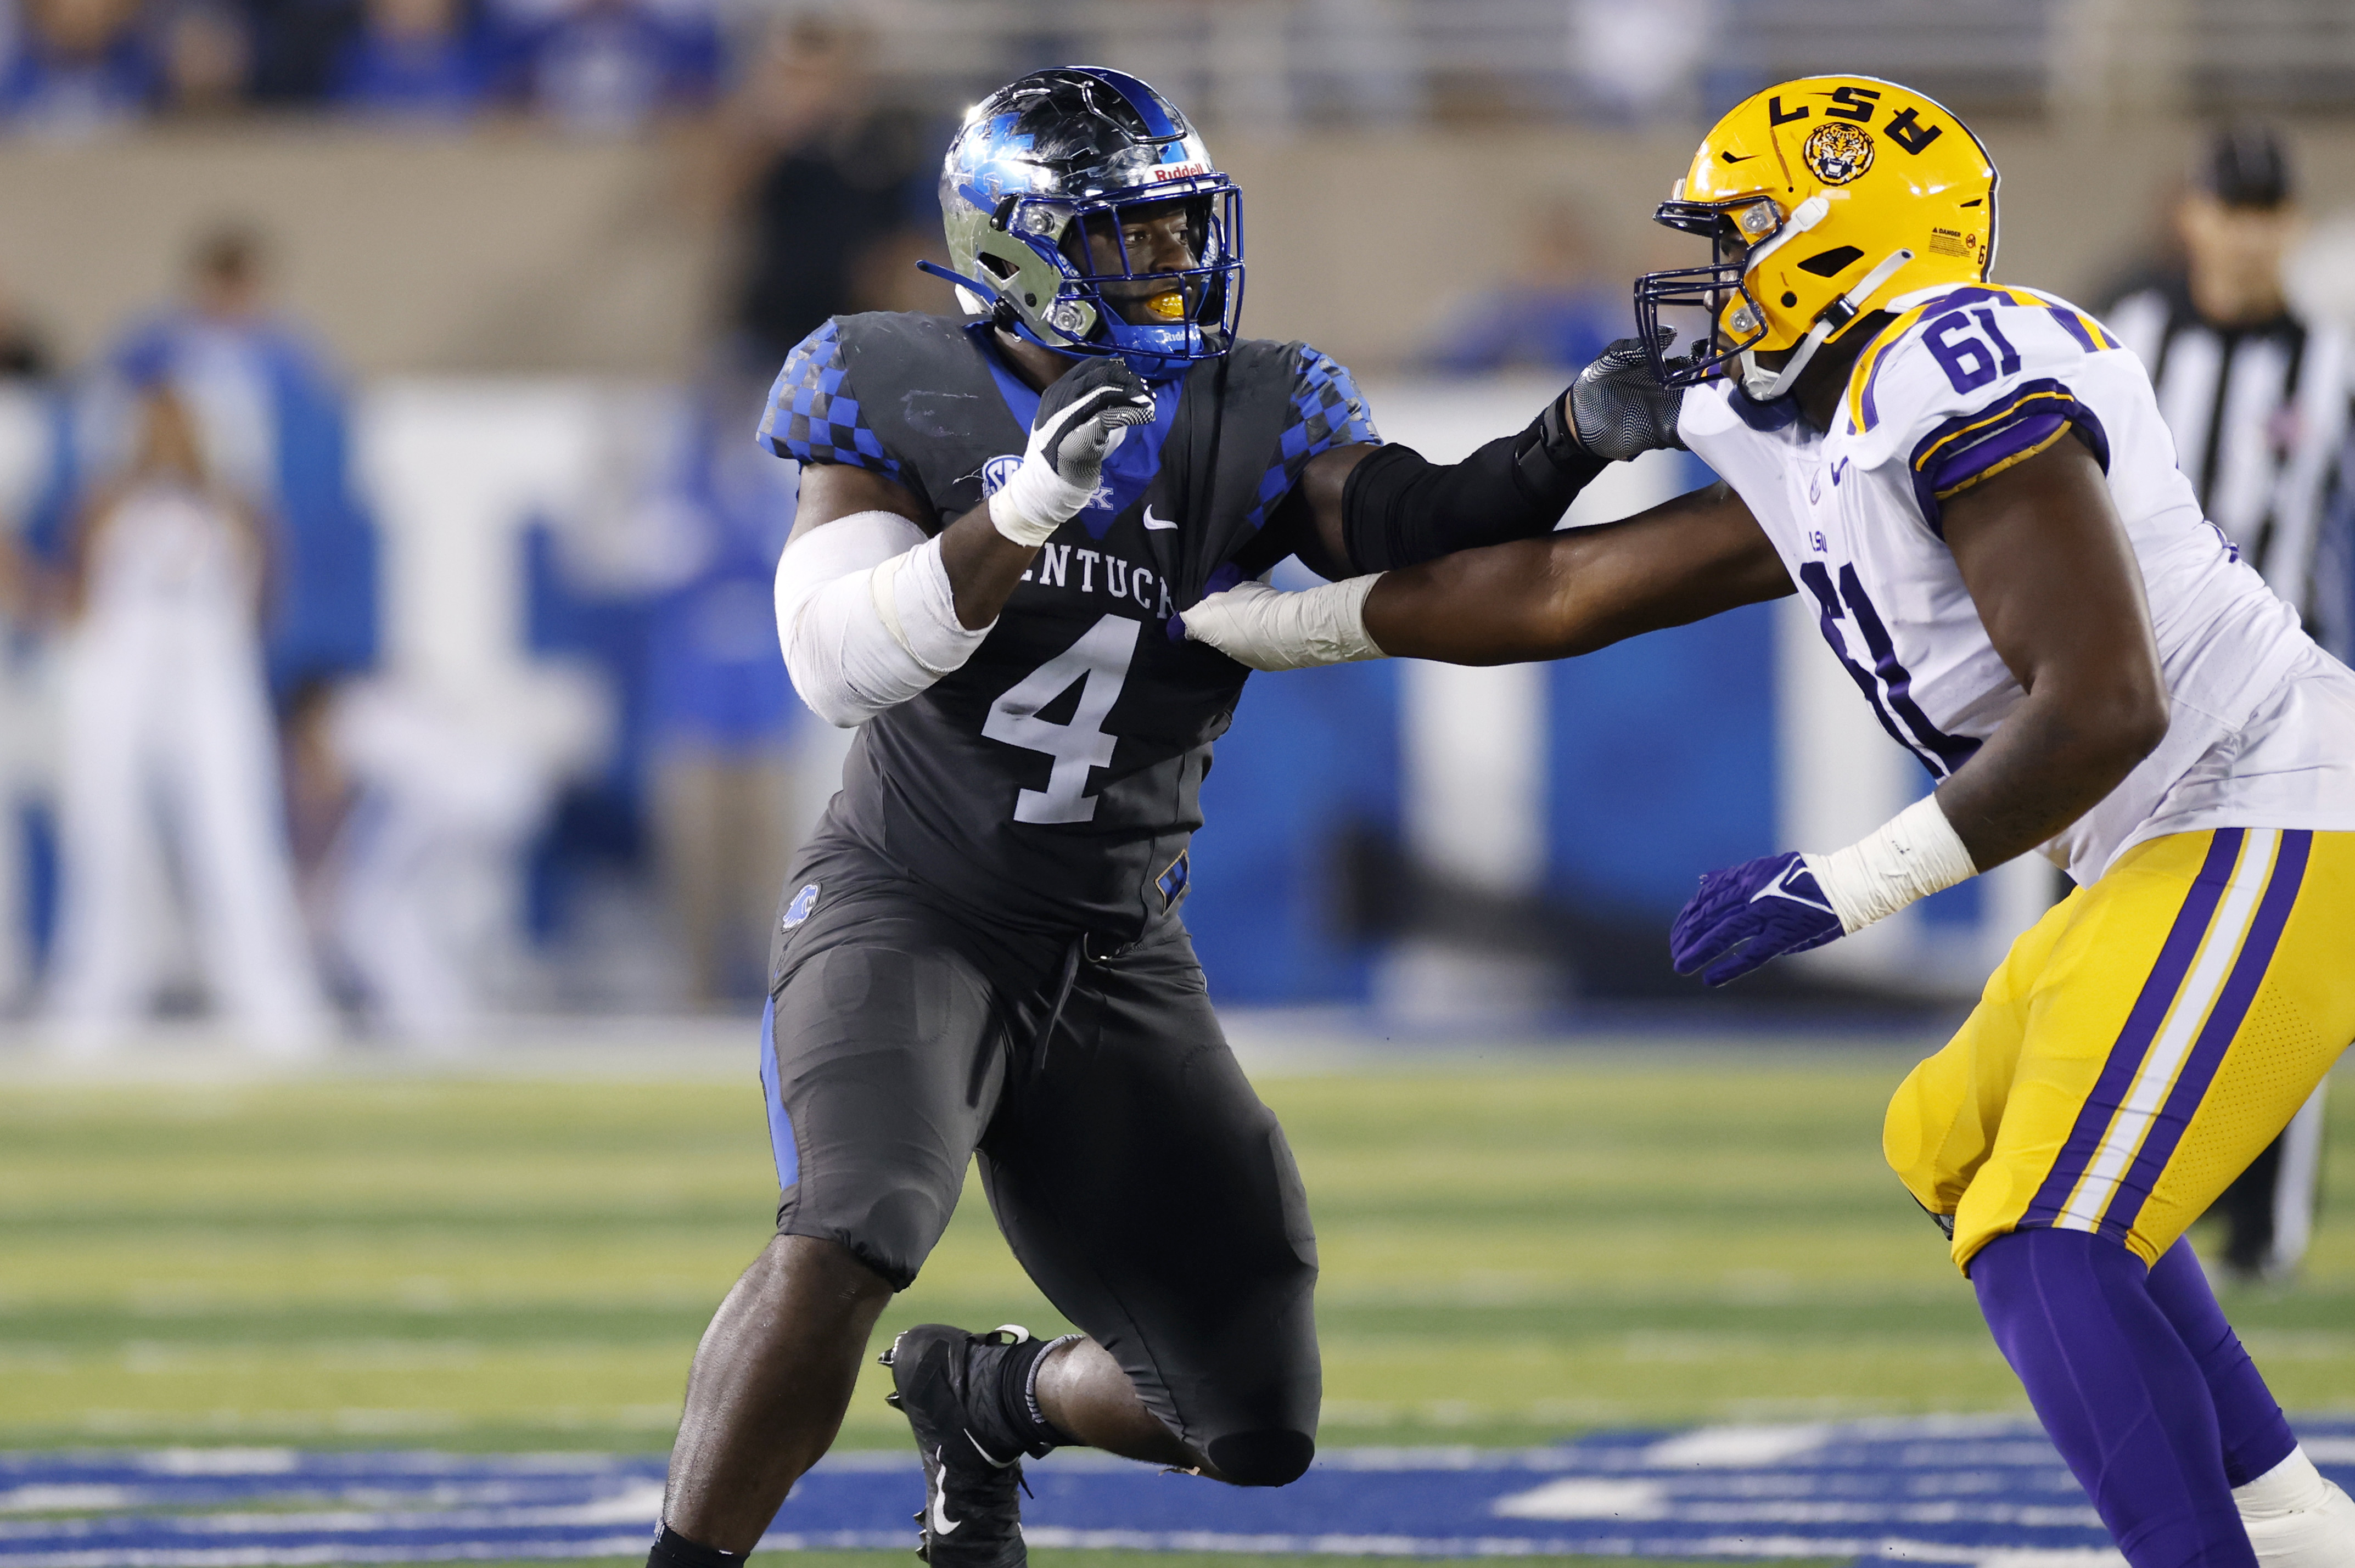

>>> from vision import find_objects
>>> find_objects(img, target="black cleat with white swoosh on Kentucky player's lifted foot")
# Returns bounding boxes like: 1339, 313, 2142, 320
878, 1323, 1029, 1568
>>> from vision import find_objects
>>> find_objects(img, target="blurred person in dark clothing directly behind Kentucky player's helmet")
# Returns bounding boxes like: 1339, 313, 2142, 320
725, 16, 947, 365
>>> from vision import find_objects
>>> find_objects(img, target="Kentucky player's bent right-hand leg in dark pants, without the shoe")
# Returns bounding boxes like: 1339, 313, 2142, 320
982, 928, 1324, 1486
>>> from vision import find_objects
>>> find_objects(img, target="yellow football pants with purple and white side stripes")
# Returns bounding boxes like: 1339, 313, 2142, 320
1882, 829, 2355, 1271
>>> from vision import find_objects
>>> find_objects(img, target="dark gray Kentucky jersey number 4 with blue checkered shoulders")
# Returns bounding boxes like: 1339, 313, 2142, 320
761, 313, 1380, 944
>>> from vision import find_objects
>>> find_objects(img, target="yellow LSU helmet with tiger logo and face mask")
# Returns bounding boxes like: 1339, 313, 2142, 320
1634, 75, 1995, 400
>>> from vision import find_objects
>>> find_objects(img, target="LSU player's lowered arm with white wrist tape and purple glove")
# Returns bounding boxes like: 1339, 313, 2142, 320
1667, 440, 2169, 986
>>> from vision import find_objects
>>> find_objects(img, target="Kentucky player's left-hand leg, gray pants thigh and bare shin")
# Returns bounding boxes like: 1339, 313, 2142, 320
652, 867, 1006, 1568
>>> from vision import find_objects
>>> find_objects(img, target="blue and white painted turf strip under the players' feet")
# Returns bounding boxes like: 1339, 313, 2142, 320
14, 1417, 2355, 1568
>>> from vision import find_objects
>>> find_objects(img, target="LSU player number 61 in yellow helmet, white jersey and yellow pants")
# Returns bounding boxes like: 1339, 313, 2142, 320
1185, 78, 2355, 1568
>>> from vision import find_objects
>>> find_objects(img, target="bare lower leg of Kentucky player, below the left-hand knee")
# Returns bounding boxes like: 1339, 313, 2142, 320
657, 1236, 893, 1568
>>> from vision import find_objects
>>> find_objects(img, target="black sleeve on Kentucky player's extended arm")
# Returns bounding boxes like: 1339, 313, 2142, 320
1340, 398, 1608, 572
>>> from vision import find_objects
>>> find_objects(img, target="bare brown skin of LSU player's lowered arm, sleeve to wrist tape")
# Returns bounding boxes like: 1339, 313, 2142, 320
1938, 440, 2169, 867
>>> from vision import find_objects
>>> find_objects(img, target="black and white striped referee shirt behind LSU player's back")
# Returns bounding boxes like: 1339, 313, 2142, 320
2103, 283, 2355, 655
